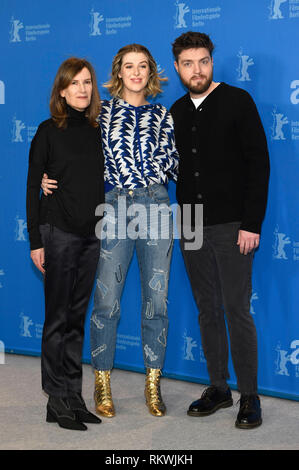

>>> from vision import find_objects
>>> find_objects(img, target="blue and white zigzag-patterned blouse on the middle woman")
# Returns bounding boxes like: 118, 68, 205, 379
100, 98, 179, 190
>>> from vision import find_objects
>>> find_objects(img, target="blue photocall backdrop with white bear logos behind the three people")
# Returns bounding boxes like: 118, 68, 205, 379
0, 0, 299, 400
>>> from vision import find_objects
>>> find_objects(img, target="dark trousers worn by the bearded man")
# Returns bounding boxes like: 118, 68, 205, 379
181, 222, 257, 394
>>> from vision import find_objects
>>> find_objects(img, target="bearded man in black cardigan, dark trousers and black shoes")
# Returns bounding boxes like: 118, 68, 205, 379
170, 32, 269, 429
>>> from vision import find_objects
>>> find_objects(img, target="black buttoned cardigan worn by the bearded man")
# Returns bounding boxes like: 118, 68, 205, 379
170, 83, 269, 233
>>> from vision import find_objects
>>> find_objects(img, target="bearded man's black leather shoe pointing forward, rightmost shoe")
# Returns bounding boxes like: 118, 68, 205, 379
235, 395, 263, 429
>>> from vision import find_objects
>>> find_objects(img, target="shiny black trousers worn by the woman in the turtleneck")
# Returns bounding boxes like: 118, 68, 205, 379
40, 224, 100, 397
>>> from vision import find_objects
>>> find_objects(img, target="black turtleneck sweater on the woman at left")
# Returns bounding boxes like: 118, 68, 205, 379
27, 107, 104, 250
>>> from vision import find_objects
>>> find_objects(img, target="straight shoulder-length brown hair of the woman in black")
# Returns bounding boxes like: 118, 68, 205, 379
50, 57, 101, 128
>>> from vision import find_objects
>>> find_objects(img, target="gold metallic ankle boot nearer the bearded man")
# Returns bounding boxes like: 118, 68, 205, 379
144, 369, 166, 416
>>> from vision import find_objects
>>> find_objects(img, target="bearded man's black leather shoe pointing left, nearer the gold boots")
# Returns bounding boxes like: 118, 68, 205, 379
187, 385, 233, 416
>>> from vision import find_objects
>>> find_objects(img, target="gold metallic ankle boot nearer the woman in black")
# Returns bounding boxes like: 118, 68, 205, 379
94, 370, 115, 418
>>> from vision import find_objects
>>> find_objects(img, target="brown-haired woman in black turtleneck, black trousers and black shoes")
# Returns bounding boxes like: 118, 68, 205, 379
27, 58, 104, 430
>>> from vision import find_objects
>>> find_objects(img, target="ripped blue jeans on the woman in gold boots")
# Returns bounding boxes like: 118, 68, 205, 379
90, 184, 173, 370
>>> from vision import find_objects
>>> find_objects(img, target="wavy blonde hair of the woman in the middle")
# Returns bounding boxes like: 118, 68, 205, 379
103, 44, 168, 98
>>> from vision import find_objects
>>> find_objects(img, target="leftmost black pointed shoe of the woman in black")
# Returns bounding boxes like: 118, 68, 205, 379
46, 396, 87, 431
